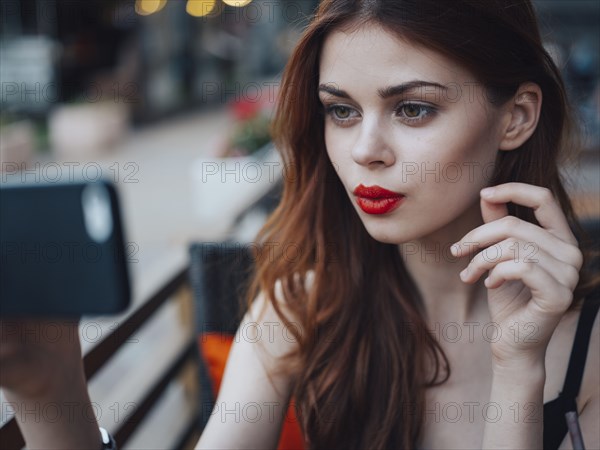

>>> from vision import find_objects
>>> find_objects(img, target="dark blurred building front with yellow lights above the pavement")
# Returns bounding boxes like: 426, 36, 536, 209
0, 0, 317, 123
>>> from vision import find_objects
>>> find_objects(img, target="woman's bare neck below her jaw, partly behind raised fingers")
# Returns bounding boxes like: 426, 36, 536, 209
399, 205, 487, 323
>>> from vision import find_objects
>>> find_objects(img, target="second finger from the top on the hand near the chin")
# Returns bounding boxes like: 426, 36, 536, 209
451, 216, 583, 270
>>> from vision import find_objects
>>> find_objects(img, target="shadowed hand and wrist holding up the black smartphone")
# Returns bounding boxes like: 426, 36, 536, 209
0, 318, 102, 449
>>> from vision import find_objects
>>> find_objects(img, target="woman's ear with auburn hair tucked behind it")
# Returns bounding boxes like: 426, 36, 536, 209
499, 83, 542, 150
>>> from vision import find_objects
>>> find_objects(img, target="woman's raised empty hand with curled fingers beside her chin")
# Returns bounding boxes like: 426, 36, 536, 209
452, 182, 583, 367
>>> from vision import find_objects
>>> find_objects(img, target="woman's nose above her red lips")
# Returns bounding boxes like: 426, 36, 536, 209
352, 119, 396, 167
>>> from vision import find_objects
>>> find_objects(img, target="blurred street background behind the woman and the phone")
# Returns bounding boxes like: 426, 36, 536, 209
0, 0, 600, 448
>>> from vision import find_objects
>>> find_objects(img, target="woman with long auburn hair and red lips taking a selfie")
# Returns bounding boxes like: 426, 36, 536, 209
2, 0, 600, 449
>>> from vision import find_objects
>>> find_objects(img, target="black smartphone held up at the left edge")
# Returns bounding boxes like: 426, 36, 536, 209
0, 180, 131, 318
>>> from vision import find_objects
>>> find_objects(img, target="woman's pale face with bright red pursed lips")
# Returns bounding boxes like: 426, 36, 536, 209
319, 25, 506, 244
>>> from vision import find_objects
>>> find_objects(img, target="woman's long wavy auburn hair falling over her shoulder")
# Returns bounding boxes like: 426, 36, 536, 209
246, 0, 597, 449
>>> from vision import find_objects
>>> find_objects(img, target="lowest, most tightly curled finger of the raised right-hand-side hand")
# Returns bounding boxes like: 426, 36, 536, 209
485, 261, 573, 315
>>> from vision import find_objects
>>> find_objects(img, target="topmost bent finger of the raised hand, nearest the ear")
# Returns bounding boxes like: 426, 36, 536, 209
481, 182, 577, 245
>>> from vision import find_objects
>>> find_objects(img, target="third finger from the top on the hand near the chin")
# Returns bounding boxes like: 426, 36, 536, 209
461, 238, 579, 290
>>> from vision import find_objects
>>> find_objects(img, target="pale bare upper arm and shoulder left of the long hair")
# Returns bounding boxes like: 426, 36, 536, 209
196, 272, 312, 449
